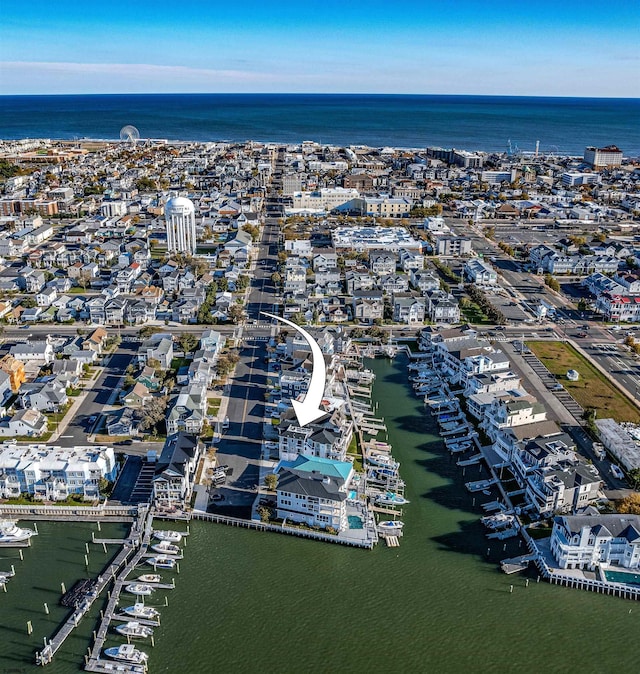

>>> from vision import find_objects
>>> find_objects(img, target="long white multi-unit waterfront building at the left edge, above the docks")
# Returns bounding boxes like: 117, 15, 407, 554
0, 442, 118, 501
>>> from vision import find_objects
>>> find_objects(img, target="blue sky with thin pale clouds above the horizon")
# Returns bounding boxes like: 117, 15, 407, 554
0, 0, 640, 97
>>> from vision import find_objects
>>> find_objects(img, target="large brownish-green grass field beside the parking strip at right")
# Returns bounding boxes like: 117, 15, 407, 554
527, 341, 640, 423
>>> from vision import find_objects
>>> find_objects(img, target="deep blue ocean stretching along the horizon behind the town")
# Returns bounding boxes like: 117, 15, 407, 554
0, 94, 640, 156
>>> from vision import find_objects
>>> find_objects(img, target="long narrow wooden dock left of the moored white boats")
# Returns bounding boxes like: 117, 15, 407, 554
36, 506, 151, 660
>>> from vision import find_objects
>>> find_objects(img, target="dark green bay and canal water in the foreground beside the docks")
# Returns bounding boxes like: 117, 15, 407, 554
0, 359, 640, 674
